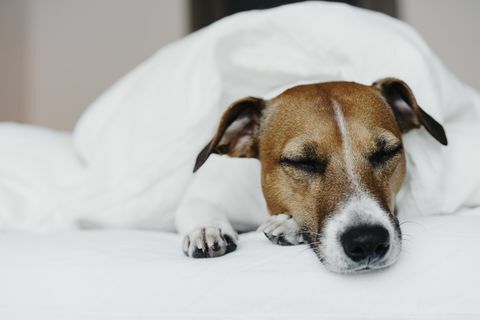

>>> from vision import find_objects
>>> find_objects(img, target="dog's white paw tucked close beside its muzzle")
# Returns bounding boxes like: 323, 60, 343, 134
257, 213, 306, 246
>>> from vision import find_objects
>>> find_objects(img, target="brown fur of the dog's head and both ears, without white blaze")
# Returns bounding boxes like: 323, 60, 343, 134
196, 78, 446, 232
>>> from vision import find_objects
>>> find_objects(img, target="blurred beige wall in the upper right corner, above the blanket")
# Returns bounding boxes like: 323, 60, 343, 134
398, 0, 480, 91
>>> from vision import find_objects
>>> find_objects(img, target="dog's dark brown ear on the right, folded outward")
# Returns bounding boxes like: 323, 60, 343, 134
372, 78, 448, 146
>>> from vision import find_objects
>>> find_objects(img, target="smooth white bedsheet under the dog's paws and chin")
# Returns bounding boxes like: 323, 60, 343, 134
0, 212, 480, 320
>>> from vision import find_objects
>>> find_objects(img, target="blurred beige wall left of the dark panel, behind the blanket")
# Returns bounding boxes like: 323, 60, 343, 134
0, 0, 189, 130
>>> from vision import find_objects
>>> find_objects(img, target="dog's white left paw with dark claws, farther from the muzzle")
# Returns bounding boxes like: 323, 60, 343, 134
183, 227, 238, 258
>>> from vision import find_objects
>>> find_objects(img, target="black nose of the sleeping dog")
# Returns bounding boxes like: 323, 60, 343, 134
340, 225, 390, 261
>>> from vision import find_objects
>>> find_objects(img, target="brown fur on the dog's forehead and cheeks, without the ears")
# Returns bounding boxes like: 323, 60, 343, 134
259, 82, 405, 232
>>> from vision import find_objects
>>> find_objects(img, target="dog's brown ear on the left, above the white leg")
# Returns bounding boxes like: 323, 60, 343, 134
193, 97, 265, 172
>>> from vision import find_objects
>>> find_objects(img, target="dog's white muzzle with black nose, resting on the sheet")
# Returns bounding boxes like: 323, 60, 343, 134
313, 195, 401, 273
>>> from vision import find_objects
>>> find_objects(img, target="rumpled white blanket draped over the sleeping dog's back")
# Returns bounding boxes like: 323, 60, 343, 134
0, 2, 480, 230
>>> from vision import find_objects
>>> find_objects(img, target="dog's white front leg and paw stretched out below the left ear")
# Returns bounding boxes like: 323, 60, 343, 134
175, 155, 267, 258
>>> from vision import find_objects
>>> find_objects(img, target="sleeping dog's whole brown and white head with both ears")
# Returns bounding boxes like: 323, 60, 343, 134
194, 78, 447, 273
